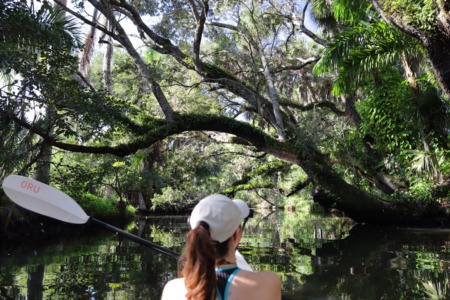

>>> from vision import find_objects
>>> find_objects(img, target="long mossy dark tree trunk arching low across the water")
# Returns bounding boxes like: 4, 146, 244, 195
14, 94, 450, 226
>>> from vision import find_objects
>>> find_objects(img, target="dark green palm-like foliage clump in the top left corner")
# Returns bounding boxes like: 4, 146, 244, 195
0, 0, 80, 68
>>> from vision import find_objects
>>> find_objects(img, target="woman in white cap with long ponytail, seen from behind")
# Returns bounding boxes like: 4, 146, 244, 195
162, 194, 281, 300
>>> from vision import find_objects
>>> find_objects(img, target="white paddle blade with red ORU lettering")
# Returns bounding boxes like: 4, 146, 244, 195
3, 175, 89, 224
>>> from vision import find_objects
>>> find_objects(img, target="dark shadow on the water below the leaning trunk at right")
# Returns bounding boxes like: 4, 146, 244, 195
286, 225, 450, 299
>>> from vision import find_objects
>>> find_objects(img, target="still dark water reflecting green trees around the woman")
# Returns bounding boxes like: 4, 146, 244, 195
0, 211, 450, 300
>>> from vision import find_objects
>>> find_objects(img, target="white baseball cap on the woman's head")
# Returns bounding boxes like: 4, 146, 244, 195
189, 194, 250, 243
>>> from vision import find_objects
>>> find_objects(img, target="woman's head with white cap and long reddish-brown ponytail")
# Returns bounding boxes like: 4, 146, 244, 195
182, 194, 249, 300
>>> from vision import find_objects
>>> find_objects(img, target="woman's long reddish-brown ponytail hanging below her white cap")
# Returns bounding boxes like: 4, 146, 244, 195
181, 221, 228, 300
